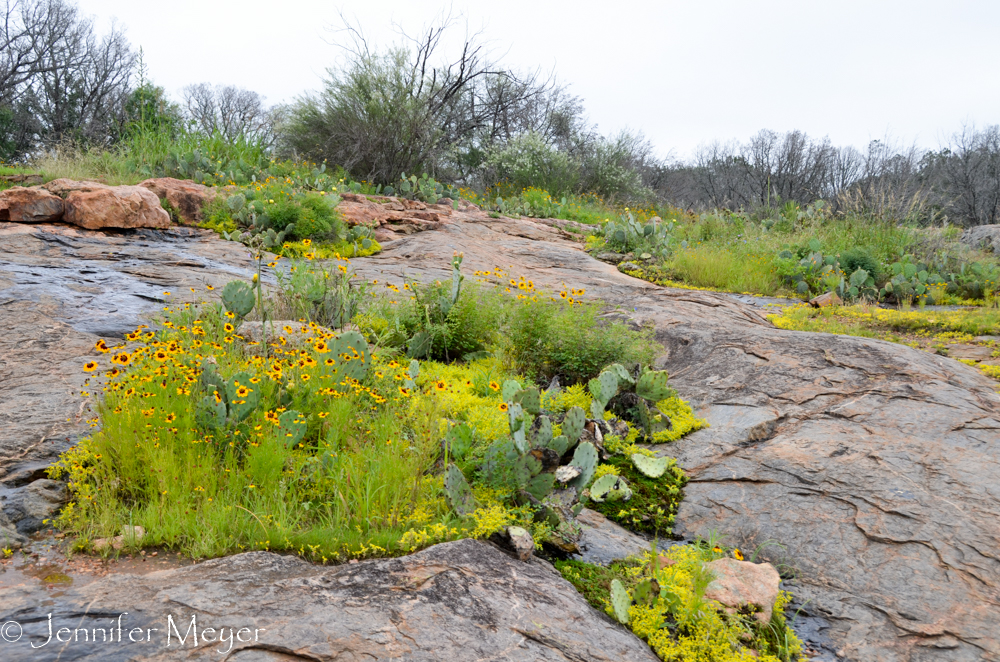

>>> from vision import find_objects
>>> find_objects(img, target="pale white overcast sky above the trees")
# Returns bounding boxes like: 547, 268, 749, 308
79, 0, 1000, 158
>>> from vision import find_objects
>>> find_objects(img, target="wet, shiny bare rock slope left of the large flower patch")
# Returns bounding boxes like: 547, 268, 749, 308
0, 223, 258, 478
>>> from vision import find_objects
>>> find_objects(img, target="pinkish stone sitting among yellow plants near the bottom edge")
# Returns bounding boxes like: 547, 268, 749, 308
705, 558, 781, 625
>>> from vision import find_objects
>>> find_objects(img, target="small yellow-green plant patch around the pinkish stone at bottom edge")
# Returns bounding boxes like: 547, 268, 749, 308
556, 541, 804, 662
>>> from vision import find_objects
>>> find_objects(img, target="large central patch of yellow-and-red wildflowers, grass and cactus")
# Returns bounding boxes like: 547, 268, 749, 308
50, 258, 696, 562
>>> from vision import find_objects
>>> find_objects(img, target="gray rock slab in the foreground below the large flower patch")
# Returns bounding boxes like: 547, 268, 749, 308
0, 540, 658, 662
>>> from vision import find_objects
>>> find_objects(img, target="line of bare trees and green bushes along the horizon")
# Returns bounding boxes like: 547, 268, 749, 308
0, 0, 1000, 225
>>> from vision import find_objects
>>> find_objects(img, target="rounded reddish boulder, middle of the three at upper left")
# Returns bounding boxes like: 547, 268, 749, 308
63, 186, 170, 230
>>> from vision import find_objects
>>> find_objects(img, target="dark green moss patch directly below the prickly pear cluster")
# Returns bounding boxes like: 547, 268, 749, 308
587, 455, 688, 536
